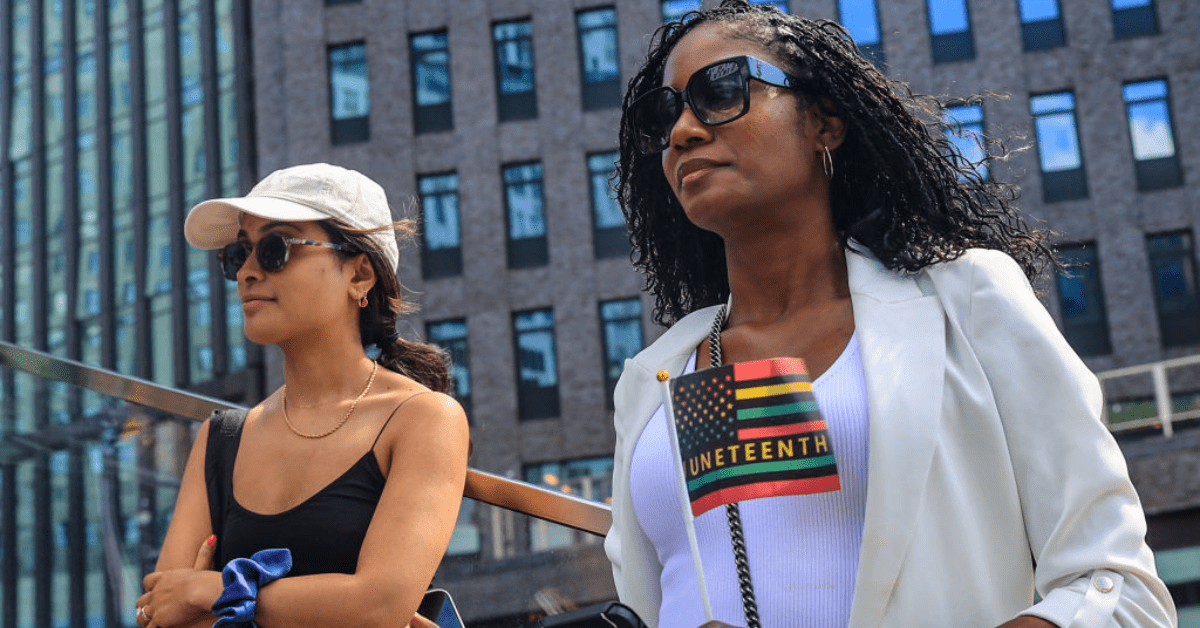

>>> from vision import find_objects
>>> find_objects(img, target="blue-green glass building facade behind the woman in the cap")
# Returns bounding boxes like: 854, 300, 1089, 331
0, 0, 259, 628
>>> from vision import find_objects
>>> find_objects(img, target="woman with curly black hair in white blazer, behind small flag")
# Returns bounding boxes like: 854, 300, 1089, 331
605, 0, 1176, 628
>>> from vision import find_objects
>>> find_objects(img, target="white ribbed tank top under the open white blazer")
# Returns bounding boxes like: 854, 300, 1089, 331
630, 334, 869, 628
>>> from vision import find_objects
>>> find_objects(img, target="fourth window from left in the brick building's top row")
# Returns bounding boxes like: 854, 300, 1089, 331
575, 6, 622, 110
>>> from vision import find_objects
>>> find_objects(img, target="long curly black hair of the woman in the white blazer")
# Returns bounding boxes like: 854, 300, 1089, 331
613, 0, 1057, 325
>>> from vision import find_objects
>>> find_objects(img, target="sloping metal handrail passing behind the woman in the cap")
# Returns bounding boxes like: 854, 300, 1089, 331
0, 342, 612, 537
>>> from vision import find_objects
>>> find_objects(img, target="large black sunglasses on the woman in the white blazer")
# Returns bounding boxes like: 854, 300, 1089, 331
629, 55, 800, 155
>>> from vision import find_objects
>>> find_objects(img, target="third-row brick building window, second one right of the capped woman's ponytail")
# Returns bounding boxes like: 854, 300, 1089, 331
512, 310, 559, 420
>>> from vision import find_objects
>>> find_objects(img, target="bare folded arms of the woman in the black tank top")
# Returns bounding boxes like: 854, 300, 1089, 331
138, 394, 469, 628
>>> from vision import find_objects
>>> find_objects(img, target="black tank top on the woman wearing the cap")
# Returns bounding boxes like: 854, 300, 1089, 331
204, 408, 400, 576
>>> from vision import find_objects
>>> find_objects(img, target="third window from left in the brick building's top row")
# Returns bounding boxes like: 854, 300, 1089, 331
492, 19, 538, 122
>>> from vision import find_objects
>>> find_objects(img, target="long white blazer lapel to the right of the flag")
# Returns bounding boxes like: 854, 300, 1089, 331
847, 251, 946, 628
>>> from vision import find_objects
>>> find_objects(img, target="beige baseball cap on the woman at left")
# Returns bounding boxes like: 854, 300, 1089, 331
184, 163, 400, 273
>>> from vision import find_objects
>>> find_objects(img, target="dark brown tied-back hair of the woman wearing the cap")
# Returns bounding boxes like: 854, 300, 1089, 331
320, 220, 451, 393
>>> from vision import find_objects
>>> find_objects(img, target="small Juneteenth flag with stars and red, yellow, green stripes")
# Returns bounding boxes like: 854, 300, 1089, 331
671, 358, 841, 516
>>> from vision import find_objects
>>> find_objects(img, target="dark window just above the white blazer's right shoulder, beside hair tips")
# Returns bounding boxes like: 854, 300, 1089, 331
1056, 243, 1112, 355
